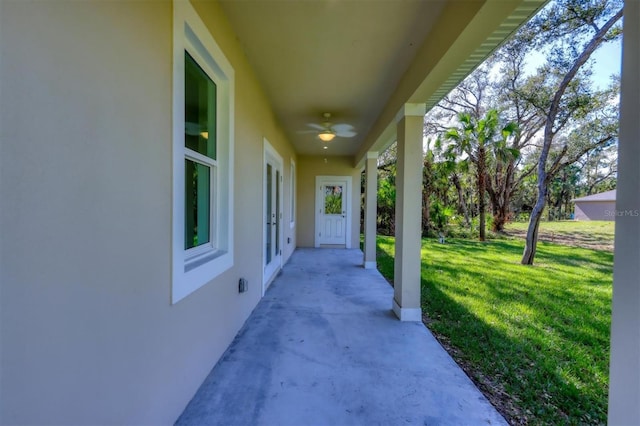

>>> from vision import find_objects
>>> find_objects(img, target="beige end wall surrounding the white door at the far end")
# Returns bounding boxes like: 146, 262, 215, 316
297, 156, 361, 248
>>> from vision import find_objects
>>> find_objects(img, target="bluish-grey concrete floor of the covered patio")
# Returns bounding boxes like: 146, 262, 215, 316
176, 249, 506, 426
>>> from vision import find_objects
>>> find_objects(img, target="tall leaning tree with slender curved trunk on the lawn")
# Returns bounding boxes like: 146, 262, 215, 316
517, 0, 623, 265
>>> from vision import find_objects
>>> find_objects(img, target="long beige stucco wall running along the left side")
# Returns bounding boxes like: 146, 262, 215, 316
0, 0, 301, 424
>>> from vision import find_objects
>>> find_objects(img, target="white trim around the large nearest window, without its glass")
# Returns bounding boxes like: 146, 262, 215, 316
171, 0, 235, 303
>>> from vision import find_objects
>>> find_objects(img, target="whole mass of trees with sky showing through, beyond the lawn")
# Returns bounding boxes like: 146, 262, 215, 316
370, 0, 623, 253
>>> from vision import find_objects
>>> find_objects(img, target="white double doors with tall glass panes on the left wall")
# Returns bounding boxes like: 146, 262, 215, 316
262, 140, 283, 294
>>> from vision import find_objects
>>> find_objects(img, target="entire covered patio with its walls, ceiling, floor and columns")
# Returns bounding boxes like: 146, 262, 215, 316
0, 0, 640, 425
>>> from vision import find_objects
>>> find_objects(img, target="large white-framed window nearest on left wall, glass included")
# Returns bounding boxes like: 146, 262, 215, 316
171, 1, 234, 303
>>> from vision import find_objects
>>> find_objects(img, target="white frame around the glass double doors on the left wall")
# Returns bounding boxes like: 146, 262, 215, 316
261, 138, 284, 296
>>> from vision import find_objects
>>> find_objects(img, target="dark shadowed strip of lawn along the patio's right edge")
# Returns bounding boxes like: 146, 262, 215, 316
423, 282, 606, 424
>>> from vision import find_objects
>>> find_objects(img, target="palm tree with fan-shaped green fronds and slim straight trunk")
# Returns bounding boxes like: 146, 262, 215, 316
444, 109, 518, 241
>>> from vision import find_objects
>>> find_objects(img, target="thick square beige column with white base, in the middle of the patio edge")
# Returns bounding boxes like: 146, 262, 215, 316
393, 104, 425, 321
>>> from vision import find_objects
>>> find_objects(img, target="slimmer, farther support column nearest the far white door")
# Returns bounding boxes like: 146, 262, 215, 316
364, 152, 378, 269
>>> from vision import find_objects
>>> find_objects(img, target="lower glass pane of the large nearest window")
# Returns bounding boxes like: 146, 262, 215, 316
184, 160, 211, 250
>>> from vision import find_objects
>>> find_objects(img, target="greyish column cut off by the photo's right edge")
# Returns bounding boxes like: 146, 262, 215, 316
608, 0, 640, 425
